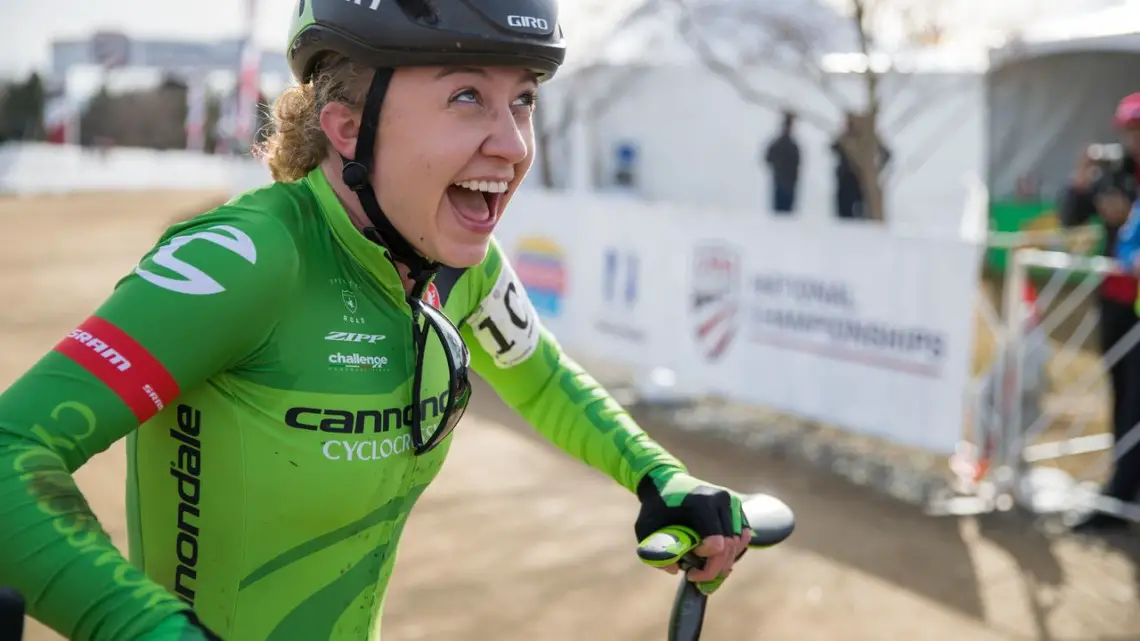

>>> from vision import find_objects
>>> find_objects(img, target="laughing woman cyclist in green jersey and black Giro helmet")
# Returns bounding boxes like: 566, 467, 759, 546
0, 0, 748, 641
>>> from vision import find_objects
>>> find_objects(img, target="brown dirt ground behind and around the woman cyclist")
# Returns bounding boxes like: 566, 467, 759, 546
0, 194, 1140, 641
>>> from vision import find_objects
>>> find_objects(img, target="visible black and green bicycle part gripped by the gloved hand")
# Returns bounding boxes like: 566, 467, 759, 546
637, 494, 796, 641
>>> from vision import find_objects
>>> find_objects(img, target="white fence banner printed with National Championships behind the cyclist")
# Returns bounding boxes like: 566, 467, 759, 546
497, 192, 982, 454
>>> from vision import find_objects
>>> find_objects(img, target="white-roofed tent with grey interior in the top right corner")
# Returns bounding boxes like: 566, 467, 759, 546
987, 0, 1140, 200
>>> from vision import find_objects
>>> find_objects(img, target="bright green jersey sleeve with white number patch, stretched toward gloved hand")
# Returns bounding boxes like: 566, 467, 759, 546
462, 237, 684, 492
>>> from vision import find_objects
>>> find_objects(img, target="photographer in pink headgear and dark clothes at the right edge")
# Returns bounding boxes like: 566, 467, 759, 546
1058, 94, 1140, 532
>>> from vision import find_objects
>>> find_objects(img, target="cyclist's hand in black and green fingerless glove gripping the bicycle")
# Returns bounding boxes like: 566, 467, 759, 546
634, 468, 751, 594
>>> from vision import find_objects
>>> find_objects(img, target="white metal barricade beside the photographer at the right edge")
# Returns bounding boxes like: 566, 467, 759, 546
992, 249, 1140, 521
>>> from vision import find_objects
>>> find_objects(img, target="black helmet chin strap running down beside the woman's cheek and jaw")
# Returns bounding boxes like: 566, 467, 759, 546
341, 68, 440, 298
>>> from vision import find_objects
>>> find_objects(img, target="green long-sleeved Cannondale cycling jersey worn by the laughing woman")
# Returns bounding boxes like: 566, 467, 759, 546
0, 169, 682, 641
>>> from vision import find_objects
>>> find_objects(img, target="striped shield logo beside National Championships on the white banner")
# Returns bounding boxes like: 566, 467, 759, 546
690, 243, 742, 360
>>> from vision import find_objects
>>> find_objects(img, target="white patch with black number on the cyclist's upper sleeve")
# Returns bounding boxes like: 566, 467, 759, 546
467, 261, 542, 367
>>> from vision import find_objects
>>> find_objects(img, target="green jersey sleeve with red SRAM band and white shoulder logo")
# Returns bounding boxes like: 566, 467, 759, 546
0, 200, 299, 641
